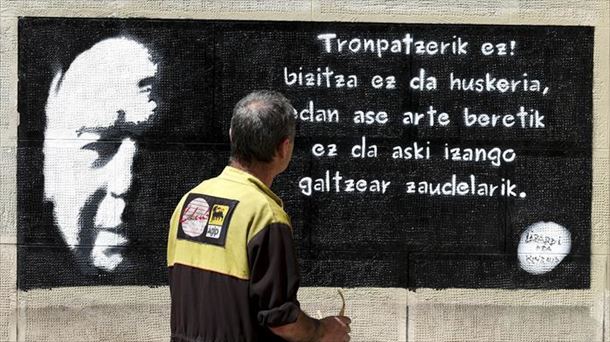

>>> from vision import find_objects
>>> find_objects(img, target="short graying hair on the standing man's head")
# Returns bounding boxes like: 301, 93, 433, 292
231, 90, 296, 163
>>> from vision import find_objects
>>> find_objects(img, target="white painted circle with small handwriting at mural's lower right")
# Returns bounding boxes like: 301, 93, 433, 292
517, 222, 572, 275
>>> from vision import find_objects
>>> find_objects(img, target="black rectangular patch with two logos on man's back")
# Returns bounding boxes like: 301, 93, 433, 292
177, 193, 238, 247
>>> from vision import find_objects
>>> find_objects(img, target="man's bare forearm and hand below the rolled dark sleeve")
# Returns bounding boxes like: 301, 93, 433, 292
269, 311, 351, 342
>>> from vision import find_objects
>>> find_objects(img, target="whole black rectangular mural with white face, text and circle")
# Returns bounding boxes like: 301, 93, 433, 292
18, 18, 593, 290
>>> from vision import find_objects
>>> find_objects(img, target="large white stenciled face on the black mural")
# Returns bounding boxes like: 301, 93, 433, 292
43, 37, 157, 272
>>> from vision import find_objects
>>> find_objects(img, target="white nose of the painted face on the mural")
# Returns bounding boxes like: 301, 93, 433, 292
108, 138, 137, 197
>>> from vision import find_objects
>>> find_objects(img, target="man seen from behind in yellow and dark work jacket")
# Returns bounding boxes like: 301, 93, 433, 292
167, 91, 350, 342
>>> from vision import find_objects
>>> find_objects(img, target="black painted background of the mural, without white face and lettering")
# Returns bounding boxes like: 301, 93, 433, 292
17, 18, 593, 289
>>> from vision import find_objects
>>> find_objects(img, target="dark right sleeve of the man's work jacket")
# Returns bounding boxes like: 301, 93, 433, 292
248, 223, 300, 326
